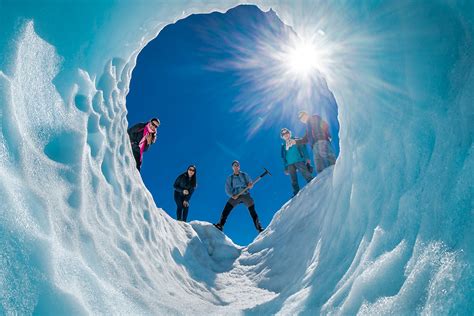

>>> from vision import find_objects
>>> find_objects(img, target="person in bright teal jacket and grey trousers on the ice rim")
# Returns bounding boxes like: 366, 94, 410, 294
281, 128, 313, 196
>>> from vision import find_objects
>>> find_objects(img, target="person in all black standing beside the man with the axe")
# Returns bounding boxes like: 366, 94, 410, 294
174, 165, 196, 222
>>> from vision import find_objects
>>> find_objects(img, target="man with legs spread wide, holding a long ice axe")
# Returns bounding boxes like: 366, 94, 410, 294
214, 160, 263, 233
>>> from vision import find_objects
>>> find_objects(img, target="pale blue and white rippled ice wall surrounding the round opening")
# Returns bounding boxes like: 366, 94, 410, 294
0, 1, 474, 314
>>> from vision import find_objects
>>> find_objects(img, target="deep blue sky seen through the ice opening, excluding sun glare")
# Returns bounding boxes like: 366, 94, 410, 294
127, 6, 339, 245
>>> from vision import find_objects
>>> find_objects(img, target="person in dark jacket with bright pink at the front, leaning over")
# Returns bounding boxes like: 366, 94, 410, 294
127, 118, 160, 171
